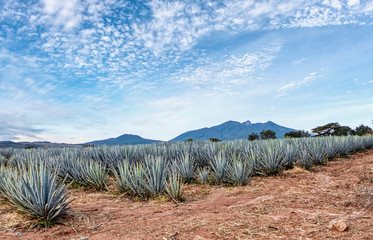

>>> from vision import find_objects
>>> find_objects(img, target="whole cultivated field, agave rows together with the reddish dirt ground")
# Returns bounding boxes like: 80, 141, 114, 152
0, 136, 373, 239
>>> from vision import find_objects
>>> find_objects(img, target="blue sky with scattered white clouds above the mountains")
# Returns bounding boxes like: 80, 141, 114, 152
0, 0, 373, 143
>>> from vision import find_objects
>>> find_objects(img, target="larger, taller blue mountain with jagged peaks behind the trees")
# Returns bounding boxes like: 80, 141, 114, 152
170, 121, 296, 142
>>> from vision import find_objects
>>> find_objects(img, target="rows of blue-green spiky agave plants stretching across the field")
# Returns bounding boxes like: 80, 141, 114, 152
0, 136, 373, 225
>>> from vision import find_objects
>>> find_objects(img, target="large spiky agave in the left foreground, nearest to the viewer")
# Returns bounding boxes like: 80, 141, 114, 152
1, 162, 71, 225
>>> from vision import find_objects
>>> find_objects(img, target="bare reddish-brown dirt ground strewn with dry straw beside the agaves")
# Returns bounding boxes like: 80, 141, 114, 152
0, 150, 373, 240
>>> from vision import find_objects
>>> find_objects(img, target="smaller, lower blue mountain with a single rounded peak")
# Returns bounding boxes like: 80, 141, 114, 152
85, 134, 160, 145
